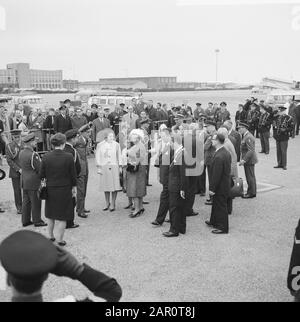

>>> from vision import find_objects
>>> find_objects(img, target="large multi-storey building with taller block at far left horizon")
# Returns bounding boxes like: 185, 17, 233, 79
0, 63, 63, 89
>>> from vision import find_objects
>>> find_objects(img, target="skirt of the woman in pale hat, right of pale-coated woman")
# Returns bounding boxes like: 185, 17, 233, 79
126, 165, 147, 198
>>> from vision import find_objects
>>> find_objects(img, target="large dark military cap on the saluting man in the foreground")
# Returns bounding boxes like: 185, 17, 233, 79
0, 230, 58, 279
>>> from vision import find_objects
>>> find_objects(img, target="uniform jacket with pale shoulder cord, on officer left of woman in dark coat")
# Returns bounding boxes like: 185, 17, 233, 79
20, 147, 41, 191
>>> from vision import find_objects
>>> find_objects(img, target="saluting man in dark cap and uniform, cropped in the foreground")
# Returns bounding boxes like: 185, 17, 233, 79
0, 230, 122, 302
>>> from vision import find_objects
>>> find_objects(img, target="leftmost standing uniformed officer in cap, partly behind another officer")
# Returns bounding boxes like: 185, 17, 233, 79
5, 130, 23, 215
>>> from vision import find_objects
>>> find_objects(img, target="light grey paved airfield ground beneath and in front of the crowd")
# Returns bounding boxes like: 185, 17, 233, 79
0, 137, 300, 302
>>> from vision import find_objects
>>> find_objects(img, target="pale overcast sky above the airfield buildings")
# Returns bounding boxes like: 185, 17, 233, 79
0, 0, 300, 82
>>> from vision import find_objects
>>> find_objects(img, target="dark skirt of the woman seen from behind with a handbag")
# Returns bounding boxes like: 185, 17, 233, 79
45, 186, 74, 221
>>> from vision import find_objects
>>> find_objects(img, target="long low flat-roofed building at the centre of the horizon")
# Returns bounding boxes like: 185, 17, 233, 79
99, 77, 177, 89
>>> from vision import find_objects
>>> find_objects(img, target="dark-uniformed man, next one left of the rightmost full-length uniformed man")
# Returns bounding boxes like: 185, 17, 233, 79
258, 105, 272, 154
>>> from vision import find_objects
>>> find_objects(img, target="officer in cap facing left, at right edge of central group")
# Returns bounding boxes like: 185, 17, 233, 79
238, 122, 258, 199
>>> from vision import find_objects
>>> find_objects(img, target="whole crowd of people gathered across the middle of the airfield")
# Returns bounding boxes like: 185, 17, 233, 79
0, 94, 300, 300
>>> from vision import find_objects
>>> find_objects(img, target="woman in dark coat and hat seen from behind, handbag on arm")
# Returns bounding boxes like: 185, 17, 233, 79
40, 133, 76, 246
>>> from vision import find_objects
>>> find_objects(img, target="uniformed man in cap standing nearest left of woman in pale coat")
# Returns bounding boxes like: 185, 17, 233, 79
75, 125, 90, 219
